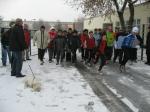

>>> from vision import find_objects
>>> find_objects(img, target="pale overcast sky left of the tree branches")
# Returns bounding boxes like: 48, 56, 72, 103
0, 0, 82, 21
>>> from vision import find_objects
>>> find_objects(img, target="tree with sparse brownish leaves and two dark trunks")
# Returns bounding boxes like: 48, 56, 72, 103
67, 0, 148, 29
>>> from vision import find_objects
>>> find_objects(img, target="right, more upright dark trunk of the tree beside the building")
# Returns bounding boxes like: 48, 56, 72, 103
128, 3, 134, 31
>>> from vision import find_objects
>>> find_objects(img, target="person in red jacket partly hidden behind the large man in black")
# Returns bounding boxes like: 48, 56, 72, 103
23, 24, 31, 61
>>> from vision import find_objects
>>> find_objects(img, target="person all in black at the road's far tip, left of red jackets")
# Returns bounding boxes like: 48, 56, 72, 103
70, 30, 80, 63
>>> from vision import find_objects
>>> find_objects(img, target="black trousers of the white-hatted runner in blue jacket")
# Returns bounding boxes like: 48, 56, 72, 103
121, 48, 131, 66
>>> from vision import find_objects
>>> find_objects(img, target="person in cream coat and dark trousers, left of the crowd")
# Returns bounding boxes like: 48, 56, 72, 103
33, 25, 50, 65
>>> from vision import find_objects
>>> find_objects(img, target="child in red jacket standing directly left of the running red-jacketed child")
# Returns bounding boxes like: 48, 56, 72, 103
87, 31, 95, 63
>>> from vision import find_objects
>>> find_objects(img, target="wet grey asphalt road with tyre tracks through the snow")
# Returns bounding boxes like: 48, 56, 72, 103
75, 62, 150, 112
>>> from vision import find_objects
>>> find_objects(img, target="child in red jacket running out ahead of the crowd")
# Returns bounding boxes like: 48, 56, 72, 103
96, 33, 107, 71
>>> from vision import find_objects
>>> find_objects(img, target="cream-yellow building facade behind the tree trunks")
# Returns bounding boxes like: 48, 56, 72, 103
84, 1, 150, 43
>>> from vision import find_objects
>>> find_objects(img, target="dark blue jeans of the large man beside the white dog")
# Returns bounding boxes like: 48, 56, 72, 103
11, 51, 23, 76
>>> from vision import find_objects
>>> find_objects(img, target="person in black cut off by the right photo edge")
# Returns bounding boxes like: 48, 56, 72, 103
145, 26, 150, 65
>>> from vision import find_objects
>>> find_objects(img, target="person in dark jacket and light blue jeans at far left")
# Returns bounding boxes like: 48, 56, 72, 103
1, 22, 15, 66
